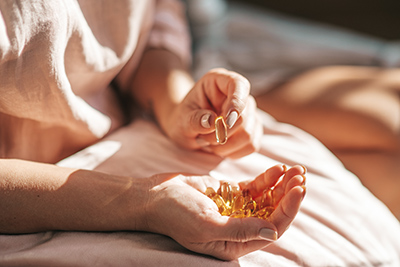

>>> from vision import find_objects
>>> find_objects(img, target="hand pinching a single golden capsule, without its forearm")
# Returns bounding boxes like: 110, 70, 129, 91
165, 69, 262, 158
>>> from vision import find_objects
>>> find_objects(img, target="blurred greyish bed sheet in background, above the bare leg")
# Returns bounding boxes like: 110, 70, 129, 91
188, 0, 400, 95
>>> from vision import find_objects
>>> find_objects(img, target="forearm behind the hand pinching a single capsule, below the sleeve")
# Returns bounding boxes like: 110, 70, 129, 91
129, 49, 194, 133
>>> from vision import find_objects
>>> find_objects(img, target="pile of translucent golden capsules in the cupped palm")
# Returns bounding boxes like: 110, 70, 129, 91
205, 182, 275, 219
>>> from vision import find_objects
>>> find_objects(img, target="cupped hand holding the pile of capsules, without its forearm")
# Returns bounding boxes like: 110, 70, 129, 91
139, 165, 305, 260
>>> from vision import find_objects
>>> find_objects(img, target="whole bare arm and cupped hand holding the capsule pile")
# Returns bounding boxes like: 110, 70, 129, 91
0, 160, 305, 260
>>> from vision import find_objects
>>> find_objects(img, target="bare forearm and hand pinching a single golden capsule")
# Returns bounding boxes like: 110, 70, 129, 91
118, 50, 262, 158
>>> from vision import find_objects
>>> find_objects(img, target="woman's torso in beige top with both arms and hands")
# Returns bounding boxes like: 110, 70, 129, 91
0, 0, 305, 259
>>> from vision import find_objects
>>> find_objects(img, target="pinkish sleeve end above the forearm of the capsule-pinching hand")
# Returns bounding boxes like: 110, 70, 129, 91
147, 0, 192, 64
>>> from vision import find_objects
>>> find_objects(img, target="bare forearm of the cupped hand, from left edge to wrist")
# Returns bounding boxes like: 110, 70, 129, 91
0, 159, 149, 233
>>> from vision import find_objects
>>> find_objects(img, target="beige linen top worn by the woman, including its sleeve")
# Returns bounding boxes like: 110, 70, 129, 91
0, 0, 190, 162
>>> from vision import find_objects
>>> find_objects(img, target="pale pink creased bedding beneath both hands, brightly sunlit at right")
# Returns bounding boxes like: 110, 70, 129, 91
0, 112, 400, 266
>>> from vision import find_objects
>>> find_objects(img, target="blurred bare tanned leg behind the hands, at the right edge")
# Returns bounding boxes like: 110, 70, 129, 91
257, 66, 400, 218
